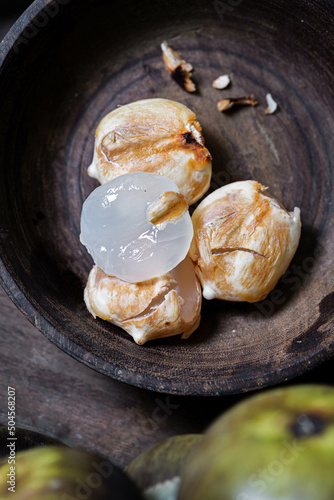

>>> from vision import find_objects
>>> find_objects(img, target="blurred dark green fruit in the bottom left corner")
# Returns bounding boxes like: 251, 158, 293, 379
0, 446, 141, 500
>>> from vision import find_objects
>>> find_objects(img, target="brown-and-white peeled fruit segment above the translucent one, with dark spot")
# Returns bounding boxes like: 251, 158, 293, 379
88, 99, 211, 205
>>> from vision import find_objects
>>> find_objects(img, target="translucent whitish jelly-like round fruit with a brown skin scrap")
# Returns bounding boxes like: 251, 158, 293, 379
80, 172, 193, 283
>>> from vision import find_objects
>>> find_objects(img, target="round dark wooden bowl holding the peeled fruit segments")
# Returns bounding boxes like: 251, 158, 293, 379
0, 0, 334, 395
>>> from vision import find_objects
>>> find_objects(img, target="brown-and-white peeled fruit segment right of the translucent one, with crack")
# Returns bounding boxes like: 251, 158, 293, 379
189, 181, 301, 302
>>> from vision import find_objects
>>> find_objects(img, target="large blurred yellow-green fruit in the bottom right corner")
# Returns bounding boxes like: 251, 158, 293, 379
179, 385, 334, 500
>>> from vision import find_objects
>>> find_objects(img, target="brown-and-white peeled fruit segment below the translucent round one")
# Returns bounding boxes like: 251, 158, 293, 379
85, 257, 201, 345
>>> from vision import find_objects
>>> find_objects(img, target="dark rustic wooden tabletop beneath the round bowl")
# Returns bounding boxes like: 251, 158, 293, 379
0, 0, 334, 467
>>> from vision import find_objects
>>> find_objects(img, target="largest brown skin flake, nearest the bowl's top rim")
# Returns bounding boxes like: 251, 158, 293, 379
161, 42, 196, 92
